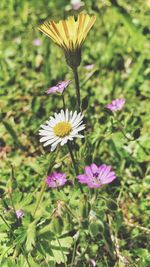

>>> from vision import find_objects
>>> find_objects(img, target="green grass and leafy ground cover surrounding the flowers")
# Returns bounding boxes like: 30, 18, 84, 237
0, 0, 150, 267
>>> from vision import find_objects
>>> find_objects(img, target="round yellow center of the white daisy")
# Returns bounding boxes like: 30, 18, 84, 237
53, 121, 72, 137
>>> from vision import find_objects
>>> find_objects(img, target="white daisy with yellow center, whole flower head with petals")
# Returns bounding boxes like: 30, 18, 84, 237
39, 109, 85, 151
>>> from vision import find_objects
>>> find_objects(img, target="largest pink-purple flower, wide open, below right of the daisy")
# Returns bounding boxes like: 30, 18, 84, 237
77, 163, 116, 188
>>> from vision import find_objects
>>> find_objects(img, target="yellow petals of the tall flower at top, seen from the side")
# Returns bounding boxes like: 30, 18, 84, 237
39, 13, 96, 53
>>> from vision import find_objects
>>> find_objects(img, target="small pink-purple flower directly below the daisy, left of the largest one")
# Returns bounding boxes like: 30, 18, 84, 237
46, 172, 67, 188
